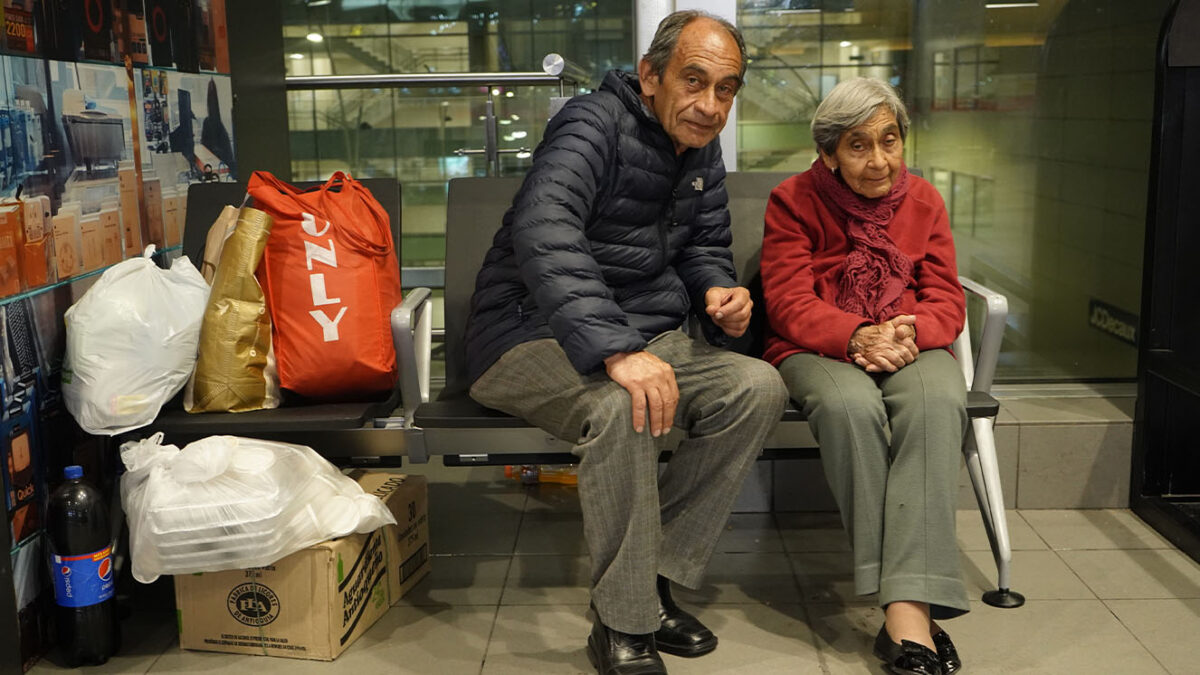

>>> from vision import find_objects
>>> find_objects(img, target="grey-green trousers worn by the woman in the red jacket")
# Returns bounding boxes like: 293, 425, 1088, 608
779, 350, 970, 619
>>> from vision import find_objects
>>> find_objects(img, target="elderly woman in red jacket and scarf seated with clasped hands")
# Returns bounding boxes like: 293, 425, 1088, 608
762, 78, 970, 675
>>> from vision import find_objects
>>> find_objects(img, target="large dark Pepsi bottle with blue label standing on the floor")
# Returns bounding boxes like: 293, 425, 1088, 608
47, 465, 121, 668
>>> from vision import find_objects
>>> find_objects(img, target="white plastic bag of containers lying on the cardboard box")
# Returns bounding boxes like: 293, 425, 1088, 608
121, 434, 396, 584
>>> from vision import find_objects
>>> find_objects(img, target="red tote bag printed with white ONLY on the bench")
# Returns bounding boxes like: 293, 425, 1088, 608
248, 171, 401, 400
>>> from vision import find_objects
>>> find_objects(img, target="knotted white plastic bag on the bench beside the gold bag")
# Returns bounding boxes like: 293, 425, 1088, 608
62, 245, 209, 436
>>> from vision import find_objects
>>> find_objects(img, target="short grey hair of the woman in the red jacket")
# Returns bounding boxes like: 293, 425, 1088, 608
812, 77, 908, 155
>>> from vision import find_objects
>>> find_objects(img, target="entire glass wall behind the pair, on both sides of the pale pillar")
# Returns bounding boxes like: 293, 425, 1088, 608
283, 0, 1170, 381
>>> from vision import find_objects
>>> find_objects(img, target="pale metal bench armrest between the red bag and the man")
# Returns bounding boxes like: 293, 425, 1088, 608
391, 287, 433, 423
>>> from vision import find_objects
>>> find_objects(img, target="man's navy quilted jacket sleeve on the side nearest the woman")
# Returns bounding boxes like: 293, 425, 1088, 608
676, 149, 737, 347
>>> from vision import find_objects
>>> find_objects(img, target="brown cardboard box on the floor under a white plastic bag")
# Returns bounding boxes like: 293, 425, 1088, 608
175, 471, 430, 661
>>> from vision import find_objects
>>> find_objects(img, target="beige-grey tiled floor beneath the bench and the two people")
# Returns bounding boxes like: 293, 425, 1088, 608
34, 470, 1200, 675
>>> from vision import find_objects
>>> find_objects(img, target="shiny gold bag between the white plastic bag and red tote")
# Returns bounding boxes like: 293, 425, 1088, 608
184, 207, 280, 412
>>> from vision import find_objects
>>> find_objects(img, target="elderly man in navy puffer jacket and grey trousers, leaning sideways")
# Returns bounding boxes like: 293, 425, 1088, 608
467, 12, 787, 674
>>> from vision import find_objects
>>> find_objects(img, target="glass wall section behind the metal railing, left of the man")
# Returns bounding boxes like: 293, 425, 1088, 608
283, 0, 634, 268
